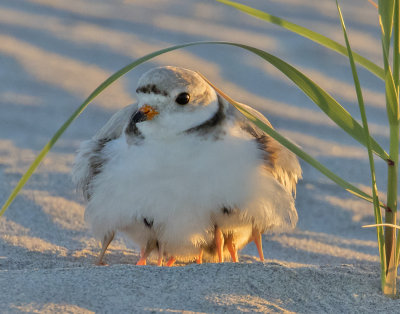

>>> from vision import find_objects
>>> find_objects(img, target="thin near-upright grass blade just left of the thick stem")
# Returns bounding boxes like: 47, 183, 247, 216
336, 0, 387, 290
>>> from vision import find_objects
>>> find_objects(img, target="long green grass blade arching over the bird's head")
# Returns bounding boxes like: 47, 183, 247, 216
0, 42, 388, 216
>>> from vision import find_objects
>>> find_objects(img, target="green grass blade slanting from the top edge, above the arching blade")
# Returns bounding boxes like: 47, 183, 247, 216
216, 0, 385, 80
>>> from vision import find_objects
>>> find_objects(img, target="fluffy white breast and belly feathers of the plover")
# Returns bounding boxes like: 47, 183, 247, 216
85, 120, 297, 256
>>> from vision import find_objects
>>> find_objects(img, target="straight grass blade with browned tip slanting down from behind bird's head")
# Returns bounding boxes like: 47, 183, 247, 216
199, 73, 373, 202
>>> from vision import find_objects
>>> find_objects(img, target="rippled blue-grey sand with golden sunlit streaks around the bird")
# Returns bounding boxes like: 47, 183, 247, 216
0, 0, 400, 313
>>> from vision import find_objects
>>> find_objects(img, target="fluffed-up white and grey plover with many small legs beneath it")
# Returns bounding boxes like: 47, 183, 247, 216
72, 66, 302, 266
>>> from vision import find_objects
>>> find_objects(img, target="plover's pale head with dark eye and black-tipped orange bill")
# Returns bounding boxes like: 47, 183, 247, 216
128, 66, 221, 137
